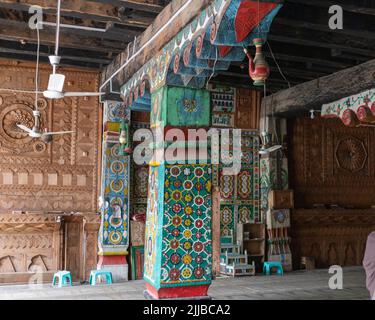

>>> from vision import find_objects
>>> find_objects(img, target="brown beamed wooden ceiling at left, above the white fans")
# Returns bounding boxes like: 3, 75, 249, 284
0, 0, 171, 70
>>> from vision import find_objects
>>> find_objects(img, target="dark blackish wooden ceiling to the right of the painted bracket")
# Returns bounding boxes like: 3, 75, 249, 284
216, 0, 375, 92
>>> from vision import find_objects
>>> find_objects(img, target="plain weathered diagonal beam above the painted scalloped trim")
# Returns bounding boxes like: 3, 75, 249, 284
102, 0, 213, 84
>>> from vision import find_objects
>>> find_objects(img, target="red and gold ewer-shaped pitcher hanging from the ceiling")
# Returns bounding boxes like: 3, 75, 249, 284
244, 38, 270, 86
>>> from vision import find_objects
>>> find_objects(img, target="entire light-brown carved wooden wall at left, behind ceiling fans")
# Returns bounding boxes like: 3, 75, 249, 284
0, 61, 101, 282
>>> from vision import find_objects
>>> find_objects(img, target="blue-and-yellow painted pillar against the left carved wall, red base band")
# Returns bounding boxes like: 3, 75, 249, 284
97, 101, 130, 281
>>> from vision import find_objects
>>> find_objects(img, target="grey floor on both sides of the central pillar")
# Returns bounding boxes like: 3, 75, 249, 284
0, 267, 369, 300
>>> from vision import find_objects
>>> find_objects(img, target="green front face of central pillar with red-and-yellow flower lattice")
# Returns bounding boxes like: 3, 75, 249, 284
161, 165, 212, 287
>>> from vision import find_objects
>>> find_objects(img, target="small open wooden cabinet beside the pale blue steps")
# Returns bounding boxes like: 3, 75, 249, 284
237, 223, 266, 272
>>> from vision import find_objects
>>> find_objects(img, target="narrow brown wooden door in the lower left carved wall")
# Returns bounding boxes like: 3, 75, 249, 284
64, 217, 84, 281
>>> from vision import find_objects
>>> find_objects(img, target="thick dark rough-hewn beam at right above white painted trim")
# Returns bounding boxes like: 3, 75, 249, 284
262, 60, 375, 116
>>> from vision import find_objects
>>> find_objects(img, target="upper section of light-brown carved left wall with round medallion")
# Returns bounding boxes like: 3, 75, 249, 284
0, 61, 100, 213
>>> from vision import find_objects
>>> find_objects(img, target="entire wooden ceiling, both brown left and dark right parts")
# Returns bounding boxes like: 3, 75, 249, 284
0, 0, 375, 92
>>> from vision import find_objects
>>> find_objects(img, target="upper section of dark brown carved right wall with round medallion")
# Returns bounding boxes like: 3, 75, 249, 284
288, 118, 375, 208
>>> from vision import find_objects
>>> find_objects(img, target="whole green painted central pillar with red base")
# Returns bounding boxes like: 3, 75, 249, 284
144, 86, 212, 299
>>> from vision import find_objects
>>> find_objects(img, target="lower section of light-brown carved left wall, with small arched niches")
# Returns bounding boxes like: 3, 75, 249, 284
0, 213, 100, 283
